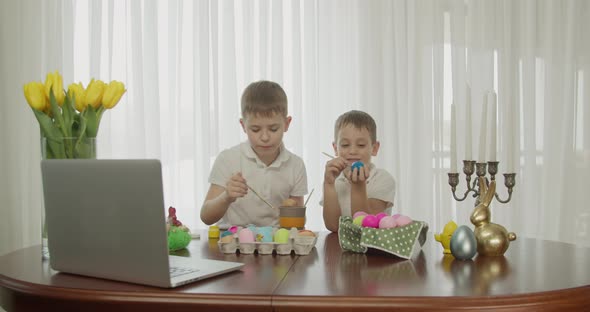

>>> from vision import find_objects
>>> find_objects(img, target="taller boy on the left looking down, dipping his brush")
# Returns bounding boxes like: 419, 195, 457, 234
201, 81, 307, 228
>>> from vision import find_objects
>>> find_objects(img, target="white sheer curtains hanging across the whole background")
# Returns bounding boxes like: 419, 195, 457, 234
0, 0, 590, 254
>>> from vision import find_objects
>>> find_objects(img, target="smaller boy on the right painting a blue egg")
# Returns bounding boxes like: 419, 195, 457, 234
321, 110, 395, 232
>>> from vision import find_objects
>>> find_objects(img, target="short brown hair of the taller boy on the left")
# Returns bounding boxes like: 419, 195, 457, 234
242, 80, 288, 118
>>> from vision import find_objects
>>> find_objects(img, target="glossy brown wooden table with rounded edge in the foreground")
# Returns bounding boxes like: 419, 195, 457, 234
0, 233, 590, 312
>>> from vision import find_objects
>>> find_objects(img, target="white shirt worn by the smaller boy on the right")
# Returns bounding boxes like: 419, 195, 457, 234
320, 164, 395, 216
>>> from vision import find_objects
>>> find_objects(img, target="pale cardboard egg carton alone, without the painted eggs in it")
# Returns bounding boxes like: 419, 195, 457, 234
217, 233, 318, 256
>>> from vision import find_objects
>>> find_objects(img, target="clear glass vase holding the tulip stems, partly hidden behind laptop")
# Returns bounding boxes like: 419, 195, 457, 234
41, 137, 96, 259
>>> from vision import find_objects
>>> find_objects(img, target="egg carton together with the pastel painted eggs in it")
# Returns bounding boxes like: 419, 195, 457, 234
218, 226, 317, 255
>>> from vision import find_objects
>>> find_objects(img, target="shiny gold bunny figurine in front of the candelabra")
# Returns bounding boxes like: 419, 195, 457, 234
470, 177, 516, 256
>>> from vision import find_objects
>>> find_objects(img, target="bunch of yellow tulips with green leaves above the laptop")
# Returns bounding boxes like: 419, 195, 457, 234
23, 71, 127, 158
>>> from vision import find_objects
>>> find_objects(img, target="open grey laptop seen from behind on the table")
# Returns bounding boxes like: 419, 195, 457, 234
41, 159, 244, 287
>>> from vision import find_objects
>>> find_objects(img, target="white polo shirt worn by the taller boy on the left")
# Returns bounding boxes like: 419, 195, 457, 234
209, 142, 307, 228
